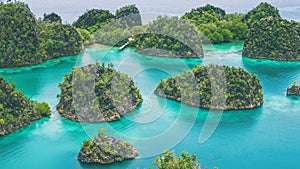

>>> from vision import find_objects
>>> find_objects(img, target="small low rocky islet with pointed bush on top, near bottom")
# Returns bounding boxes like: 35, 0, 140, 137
78, 129, 139, 164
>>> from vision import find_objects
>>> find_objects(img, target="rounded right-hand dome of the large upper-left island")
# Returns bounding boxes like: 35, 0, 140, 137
38, 23, 83, 59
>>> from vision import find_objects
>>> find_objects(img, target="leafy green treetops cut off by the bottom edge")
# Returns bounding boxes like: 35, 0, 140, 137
150, 151, 200, 169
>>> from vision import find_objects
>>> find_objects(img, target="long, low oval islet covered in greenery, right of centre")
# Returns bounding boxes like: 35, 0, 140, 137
155, 65, 263, 110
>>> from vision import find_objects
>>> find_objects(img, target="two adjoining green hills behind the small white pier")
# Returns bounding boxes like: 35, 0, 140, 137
73, 5, 144, 46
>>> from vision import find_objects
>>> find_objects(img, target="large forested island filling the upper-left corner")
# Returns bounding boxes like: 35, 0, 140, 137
0, 2, 83, 67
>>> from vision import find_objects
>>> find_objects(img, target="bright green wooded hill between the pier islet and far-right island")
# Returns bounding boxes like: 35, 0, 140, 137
182, 4, 249, 43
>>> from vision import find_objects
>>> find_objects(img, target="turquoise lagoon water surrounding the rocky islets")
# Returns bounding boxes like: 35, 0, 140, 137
0, 43, 300, 169
